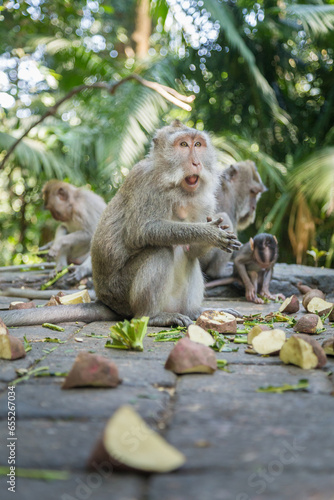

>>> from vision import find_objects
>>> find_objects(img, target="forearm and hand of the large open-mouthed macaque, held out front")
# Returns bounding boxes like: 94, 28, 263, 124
134, 219, 241, 253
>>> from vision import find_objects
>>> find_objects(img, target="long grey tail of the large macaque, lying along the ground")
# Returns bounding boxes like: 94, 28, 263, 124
0, 303, 123, 326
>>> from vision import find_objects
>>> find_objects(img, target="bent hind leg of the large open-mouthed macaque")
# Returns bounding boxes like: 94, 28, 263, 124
127, 247, 196, 326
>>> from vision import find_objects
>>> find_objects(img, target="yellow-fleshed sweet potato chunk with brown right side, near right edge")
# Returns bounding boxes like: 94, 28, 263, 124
279, 333, 327, 370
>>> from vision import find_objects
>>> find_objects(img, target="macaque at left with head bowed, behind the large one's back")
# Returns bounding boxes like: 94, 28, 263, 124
40, 180, 107, 282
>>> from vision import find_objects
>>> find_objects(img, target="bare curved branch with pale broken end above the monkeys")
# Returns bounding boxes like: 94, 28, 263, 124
0, 74, 195, 170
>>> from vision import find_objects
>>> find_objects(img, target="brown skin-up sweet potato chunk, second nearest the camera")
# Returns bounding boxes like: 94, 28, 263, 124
62, 352, 121, 389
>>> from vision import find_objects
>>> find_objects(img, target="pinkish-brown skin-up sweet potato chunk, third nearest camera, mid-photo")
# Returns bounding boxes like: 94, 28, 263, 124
165, 337, 217, 374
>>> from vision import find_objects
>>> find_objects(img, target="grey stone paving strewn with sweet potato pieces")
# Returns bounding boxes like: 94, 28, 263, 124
0, 268, 334, 500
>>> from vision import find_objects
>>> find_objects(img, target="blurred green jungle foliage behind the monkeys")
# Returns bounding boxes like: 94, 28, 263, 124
0, 0, 334, 267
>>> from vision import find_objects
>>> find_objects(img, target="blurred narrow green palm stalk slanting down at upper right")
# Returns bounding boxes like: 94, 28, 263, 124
203, 0, 289, 126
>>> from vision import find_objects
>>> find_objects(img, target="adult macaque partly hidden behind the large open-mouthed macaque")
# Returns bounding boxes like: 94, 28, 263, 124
201, 160, 267, 279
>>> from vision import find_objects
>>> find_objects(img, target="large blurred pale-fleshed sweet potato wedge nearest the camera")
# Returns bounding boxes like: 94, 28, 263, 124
88, 406, 185, 473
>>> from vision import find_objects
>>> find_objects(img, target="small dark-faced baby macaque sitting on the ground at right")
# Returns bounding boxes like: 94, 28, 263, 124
206, 233, 285, 304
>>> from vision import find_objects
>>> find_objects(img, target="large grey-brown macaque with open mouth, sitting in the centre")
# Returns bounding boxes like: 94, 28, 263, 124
2, 120, 241, 326
